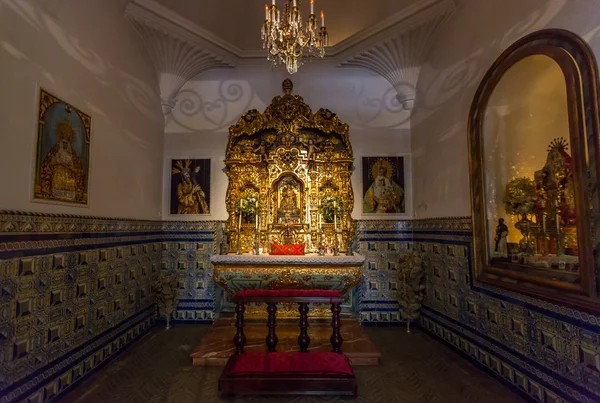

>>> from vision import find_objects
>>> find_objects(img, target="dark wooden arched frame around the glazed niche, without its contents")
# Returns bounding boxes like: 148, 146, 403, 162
468, 29, 600, 312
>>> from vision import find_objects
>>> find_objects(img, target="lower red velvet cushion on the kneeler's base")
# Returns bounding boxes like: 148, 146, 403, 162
225, 352, 354, 378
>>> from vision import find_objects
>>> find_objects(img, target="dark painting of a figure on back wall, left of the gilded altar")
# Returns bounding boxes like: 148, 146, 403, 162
169, 158, 211, 215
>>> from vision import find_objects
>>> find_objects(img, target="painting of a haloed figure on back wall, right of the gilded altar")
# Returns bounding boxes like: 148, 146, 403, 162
362, 157, 406, 214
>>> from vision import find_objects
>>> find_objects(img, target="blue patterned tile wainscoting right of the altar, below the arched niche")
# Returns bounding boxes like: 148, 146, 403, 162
356, 217, 600, 403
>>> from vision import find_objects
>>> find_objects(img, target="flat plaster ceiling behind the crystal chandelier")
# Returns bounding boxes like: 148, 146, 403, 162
156, 0, 420, 51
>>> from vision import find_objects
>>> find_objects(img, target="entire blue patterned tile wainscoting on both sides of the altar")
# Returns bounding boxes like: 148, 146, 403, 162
0, 212, 600, 403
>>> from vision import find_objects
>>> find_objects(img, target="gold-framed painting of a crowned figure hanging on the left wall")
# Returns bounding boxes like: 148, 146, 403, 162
33, 89, 92, 206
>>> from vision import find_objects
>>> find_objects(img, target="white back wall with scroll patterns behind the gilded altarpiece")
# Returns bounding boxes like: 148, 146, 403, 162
163, 66, 410, 220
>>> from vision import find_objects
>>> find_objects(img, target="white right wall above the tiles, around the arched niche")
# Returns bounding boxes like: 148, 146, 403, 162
410, 0, 600, 218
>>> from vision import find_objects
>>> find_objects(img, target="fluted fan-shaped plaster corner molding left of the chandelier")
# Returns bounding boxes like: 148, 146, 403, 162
125, 0, 236, 116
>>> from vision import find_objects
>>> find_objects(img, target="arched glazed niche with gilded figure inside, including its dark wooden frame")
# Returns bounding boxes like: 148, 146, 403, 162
469, 30, 600, 311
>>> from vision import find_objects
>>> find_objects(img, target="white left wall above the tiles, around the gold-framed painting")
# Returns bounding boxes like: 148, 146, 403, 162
0, 0, 164, 219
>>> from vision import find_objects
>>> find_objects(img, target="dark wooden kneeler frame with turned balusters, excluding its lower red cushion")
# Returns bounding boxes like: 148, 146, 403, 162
219, 296, 357, 396
